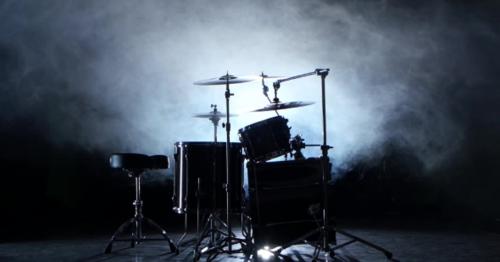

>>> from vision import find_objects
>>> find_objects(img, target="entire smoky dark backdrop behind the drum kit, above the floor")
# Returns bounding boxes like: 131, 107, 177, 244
0, 0, 500, 240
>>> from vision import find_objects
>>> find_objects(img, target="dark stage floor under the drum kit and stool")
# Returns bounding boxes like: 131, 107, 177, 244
0, 223, 500, 261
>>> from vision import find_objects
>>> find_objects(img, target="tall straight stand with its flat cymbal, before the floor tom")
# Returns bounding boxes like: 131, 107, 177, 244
194, 72, 248, 260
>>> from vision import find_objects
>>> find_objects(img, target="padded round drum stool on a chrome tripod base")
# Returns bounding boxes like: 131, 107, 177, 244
104, 153, 179, 254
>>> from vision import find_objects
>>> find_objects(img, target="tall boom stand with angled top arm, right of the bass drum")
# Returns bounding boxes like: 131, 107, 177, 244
273, 68, 392, 261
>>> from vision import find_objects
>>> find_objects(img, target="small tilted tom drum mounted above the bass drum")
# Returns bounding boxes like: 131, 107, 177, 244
238, 116, 291, 162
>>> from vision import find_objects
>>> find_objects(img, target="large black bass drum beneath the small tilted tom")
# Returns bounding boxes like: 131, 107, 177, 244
247, 158, 331, 247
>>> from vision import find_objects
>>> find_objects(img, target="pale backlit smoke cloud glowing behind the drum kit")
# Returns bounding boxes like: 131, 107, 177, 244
0, 0, 496, 174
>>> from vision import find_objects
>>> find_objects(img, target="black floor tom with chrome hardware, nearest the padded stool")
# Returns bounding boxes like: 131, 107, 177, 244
172, 142, 244, 214
